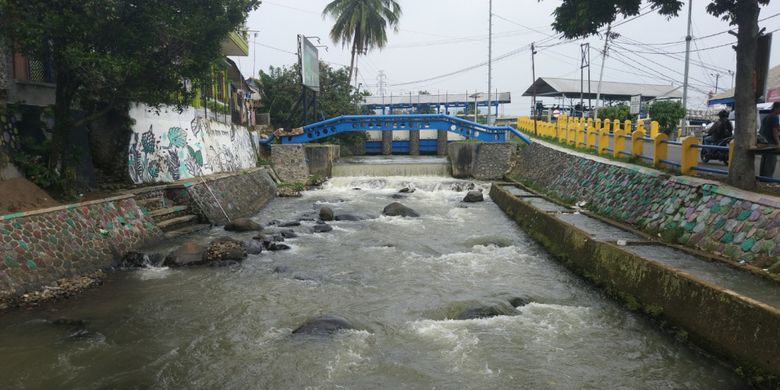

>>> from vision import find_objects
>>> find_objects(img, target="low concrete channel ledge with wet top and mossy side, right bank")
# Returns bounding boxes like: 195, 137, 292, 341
490, 183, 780, 380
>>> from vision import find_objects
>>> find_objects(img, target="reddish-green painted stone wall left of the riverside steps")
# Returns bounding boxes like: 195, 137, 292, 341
0, 195, 162, 302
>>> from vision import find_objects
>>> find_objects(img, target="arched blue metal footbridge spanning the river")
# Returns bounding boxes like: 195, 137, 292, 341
269, 114, 531, 150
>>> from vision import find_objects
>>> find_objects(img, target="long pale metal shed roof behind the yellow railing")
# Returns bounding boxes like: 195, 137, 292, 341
523, 77, 682, 100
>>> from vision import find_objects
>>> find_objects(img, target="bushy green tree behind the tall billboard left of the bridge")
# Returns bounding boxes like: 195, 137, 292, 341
258, 62, 367, 143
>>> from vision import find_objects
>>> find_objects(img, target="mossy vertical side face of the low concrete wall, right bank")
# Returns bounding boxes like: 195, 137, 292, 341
490, 185, 780, 376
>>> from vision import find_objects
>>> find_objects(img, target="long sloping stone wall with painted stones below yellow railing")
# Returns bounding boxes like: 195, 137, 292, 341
510, 142, 780, 268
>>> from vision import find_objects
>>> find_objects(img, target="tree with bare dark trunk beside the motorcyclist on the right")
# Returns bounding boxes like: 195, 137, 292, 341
553, 0, 769, 189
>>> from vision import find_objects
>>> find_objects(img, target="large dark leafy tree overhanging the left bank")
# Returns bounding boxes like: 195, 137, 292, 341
0, 0, 259, 192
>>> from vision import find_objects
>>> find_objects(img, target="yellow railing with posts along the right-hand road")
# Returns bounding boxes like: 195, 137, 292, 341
517, 115, 736, 181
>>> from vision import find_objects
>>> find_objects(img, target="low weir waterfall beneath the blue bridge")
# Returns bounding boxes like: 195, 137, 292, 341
333, 156, 450, 177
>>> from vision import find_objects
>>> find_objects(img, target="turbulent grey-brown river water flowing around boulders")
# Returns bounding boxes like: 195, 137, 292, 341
0, 177, 743, 389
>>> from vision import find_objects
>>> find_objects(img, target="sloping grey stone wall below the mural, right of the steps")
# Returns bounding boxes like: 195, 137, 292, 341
166, 168, 276, 225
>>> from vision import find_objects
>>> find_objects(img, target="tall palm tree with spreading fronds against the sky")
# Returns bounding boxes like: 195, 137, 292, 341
322, 0, 401, 82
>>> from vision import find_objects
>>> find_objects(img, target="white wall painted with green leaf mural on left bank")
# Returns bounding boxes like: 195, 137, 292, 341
128, 104, 257, 184
